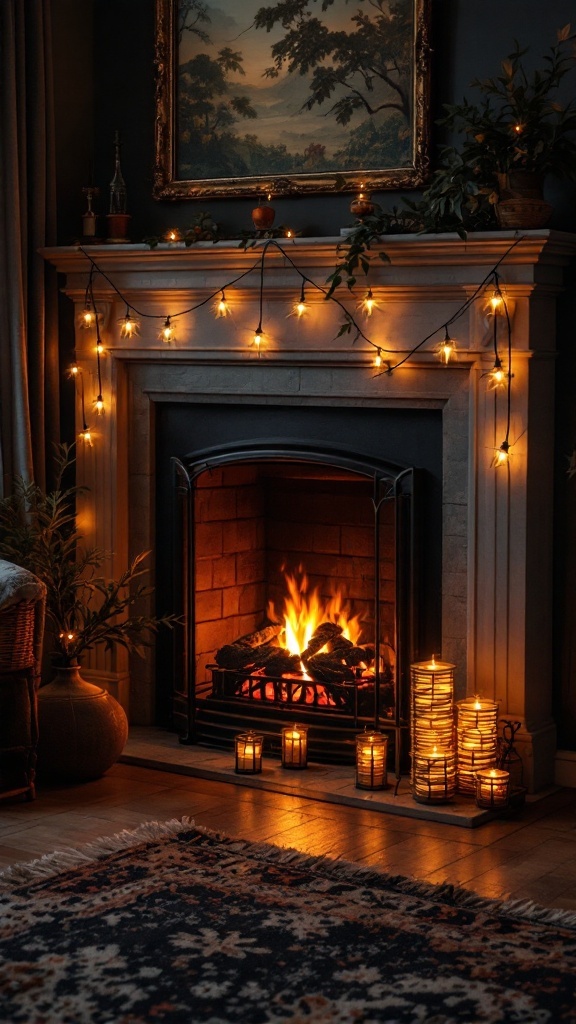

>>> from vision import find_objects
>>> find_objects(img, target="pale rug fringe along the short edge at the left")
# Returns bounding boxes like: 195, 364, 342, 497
0, 816, 194, 889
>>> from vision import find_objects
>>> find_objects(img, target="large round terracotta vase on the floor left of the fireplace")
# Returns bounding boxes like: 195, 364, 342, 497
38, 666, 128, 781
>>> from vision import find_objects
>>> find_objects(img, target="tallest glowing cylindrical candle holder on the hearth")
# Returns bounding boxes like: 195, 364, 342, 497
410, 654, 456, 804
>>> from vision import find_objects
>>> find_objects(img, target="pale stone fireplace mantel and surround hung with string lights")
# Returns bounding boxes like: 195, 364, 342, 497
43, 230, 576, 790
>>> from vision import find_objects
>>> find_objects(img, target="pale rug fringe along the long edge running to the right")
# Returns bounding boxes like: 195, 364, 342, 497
196, 825, 576, 929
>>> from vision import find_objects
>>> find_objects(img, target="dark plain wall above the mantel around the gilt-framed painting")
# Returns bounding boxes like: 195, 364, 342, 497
52, 0, 576, 243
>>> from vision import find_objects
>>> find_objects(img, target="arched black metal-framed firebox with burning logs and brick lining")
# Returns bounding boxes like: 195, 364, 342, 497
162, 428, 432, 768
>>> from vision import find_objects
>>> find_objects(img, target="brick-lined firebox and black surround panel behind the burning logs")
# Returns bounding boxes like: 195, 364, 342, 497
156, 403, 442, 757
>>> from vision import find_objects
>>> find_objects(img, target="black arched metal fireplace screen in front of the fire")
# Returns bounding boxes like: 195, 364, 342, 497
172, 440, 418, 767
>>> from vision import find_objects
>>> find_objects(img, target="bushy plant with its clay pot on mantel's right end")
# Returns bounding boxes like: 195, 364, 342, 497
439, 25, 576, 227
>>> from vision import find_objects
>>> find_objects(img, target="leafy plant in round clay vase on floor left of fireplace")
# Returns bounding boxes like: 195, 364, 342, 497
0, 444, 176, 779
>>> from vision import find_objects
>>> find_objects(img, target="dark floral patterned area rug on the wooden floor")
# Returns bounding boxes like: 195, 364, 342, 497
0, 819, 576, 1024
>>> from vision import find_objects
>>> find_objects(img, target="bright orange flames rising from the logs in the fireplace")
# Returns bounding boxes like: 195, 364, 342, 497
268, 570, 362, 654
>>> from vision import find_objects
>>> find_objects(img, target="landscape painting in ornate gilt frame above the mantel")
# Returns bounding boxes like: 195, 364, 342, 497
154, 0, 430, 200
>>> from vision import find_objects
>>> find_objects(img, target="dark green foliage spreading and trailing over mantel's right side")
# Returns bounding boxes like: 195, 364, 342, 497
328, 25, 576, 294
